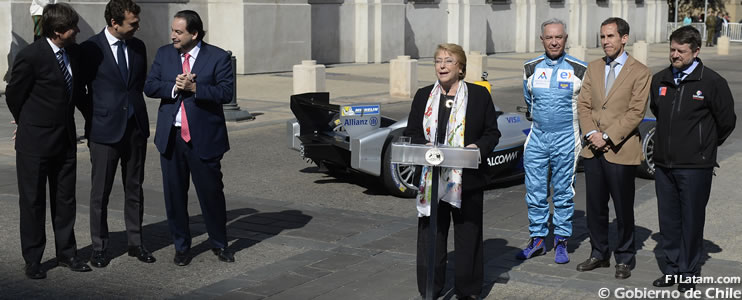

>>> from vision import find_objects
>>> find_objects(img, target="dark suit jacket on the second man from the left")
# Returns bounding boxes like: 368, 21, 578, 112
80, 29, 149, 144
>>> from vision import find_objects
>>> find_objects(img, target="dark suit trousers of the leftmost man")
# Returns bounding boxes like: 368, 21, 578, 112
16, 145, 77, 263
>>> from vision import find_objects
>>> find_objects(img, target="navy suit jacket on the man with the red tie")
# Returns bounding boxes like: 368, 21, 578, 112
144, 42, 234, 159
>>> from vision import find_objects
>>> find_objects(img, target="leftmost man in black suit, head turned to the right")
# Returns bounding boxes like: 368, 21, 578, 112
6, 3, 90, 279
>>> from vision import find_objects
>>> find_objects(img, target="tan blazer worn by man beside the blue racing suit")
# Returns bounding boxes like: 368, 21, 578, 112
577, 56, 652, 165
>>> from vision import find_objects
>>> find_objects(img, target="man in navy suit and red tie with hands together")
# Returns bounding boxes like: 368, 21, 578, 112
144, 10, 234, 266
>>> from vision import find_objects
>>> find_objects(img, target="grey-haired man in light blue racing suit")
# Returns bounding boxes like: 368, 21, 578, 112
517, 19, 587, 264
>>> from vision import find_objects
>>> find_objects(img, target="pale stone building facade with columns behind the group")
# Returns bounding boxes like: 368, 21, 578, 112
0, 0, 668, 75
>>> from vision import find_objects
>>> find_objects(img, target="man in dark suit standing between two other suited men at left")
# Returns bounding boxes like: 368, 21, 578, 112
81, 0, 155, 268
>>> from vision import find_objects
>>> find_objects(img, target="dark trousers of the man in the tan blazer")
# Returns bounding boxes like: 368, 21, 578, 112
582, 155, 636, 265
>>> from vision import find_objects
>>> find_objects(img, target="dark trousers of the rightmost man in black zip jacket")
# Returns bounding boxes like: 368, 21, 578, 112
654, 166, 713, 276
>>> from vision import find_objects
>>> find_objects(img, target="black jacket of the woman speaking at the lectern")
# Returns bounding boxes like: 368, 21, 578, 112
404, 81, 500, 191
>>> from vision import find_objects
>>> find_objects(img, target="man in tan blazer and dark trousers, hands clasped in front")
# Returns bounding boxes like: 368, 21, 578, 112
577, 18, 651, 279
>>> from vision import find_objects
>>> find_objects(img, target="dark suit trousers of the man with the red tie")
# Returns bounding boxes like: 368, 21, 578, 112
160, 126, 227, 252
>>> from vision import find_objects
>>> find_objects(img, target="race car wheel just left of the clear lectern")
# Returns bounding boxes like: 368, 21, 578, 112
381, 136, 418, 198
